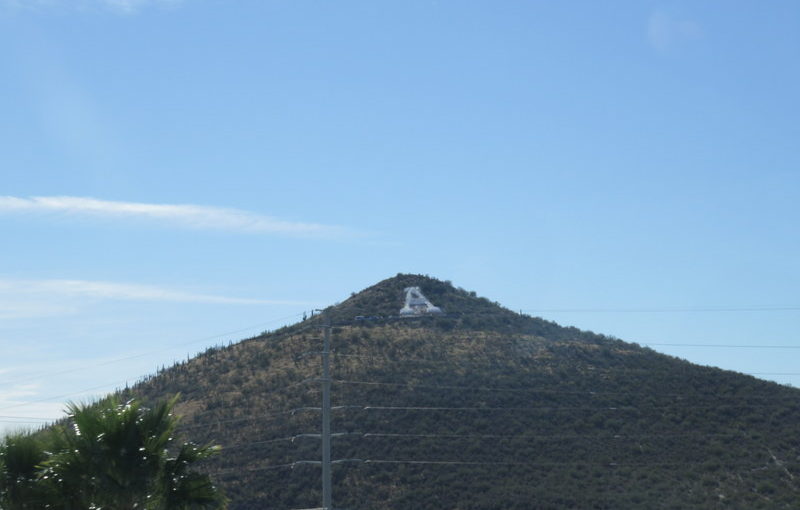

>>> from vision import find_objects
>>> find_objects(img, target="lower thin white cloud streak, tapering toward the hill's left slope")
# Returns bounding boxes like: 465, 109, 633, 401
0, 279, 308, 306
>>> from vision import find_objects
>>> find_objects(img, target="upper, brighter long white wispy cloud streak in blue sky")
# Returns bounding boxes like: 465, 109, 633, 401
0, 196, 354, 239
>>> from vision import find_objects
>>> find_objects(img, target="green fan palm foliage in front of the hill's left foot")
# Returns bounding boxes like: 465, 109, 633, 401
0, 397, 226, 510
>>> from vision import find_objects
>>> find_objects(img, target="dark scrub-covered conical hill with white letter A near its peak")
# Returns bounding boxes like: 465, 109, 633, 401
122, 275, 800, 510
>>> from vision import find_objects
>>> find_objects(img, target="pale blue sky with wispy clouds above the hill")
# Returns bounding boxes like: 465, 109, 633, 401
0, 0, 800, 434
